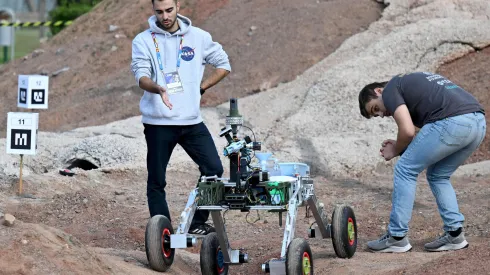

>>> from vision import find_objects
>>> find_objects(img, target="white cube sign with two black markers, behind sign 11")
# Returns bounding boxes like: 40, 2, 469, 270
17, 75, 49, 109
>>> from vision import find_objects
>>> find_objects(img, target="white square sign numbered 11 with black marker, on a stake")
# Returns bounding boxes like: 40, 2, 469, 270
6, 112, 39, 155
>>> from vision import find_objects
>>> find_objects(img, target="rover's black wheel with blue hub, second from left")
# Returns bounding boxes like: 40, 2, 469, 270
200, 232, 229, 275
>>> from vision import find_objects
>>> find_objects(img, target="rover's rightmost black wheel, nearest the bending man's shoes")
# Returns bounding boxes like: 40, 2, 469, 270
331, 205, 357, 258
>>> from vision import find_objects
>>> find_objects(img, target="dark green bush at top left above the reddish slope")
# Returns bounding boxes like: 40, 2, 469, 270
49, 0, 101, 35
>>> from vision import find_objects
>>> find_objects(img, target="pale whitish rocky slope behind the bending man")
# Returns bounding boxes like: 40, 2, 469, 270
217, 0, 490, 177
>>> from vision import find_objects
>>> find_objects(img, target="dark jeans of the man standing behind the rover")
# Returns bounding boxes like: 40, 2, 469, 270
143, 122, 223, 226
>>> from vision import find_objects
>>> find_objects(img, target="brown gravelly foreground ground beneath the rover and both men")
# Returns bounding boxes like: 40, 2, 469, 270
0, 167, 490, 274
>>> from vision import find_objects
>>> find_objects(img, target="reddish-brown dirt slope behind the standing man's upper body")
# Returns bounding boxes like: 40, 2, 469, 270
0, 0, 382, 131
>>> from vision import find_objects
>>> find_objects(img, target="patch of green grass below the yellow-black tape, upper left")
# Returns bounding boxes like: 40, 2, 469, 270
0, 28, 40, 63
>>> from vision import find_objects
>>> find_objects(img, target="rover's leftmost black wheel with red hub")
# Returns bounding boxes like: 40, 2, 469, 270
145, 215, 175, 272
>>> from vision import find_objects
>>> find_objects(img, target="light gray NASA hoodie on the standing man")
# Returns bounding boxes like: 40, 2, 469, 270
131, 14, 231, 125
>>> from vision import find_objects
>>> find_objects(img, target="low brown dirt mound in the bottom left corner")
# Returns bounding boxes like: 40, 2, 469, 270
0, 220, 110, 274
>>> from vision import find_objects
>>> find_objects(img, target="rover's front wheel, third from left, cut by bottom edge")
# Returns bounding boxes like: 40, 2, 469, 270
286, 238, 313, 275
